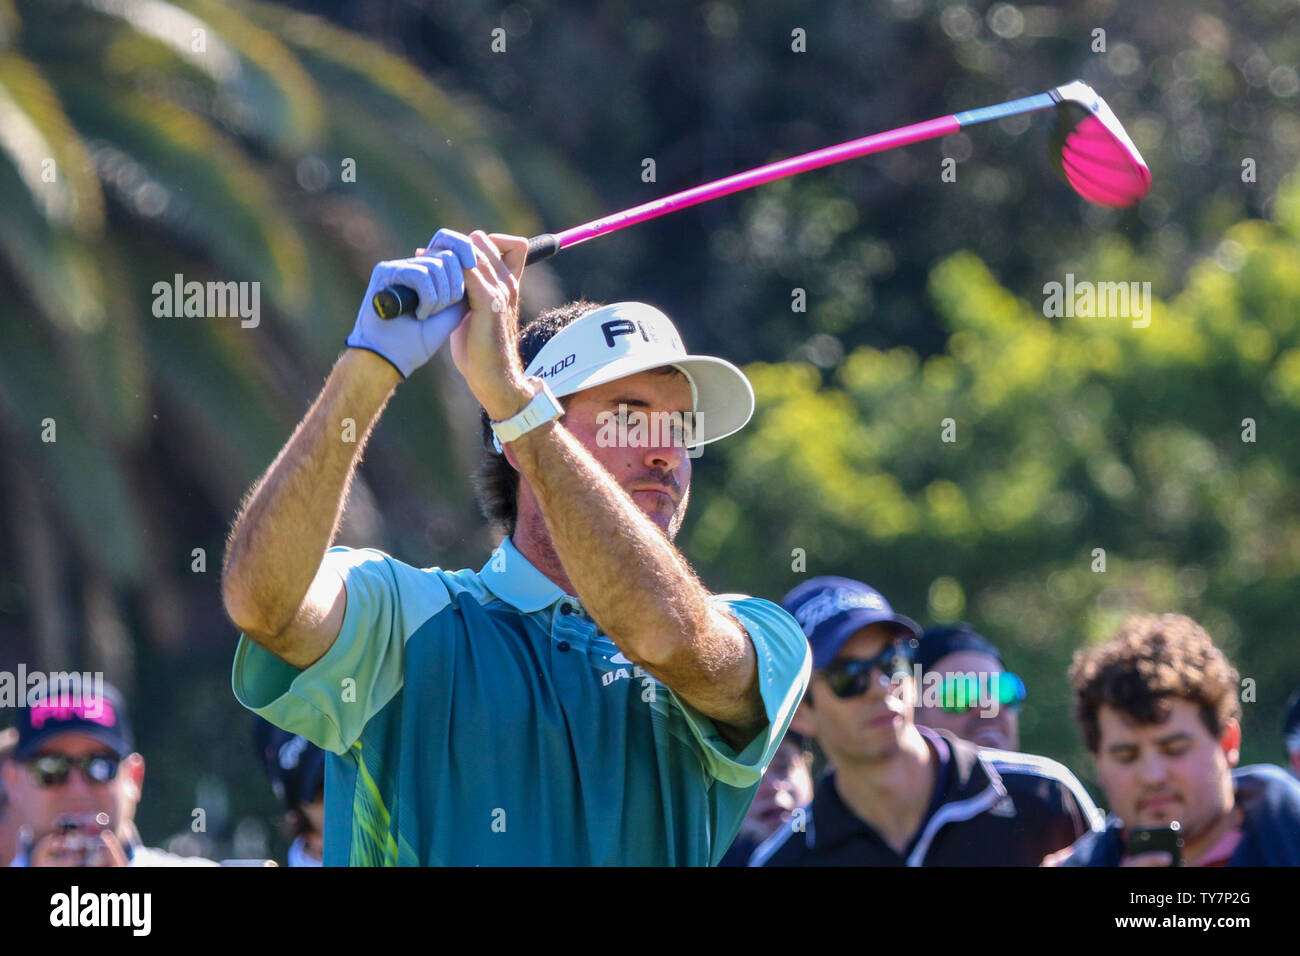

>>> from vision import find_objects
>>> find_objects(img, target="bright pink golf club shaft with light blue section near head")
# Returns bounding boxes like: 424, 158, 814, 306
374, 92, 1057, 319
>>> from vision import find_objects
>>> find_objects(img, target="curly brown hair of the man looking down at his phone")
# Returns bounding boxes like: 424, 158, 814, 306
1070, 614, 1242, 753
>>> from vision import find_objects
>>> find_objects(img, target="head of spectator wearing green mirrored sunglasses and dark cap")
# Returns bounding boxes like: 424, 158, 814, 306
917, 623, 1024, 750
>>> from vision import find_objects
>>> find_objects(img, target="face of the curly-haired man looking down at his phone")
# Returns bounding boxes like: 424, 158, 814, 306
1095, 700, 1240, 840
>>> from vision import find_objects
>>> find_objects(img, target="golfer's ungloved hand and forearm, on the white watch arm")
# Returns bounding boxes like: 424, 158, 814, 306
451, 233, 767, 744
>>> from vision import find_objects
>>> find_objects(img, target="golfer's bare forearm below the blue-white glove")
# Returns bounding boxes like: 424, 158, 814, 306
222, 349, 400, 650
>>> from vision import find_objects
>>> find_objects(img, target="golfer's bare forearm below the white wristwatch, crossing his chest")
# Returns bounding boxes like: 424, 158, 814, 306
514, 423, 766, 730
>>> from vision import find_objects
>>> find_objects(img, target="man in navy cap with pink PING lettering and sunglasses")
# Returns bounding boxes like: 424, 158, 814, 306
4, 683, 216, 866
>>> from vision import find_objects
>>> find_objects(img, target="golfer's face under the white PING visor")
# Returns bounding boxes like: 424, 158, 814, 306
564, 369, 693, 540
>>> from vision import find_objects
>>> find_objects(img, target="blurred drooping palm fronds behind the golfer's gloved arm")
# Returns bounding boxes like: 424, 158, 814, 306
0, 0, 543, 650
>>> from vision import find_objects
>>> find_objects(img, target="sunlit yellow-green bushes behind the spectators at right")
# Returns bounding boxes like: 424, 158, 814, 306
688, 174, 1300, 785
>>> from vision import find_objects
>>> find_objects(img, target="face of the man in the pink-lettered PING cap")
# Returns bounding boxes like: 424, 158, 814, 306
4, 731, 144, 839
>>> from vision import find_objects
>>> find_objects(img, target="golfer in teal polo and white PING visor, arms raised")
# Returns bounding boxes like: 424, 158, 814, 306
222, 230, 810, 866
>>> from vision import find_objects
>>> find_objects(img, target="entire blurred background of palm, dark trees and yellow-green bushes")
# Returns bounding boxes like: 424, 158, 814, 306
0, 0, 1300, 847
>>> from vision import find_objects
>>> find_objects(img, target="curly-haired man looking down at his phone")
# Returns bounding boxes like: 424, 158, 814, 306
1044, 614, 1300, 866
